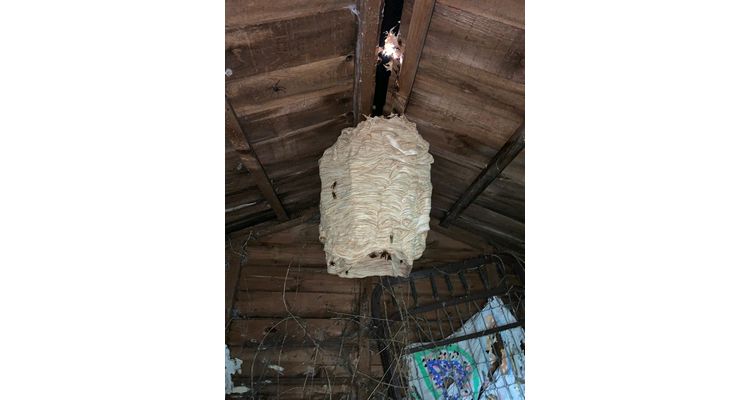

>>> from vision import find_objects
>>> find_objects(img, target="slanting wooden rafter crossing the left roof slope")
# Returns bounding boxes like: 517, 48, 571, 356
224, 98, 289, 221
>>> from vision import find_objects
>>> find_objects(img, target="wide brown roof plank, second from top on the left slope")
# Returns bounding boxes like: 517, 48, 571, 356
225, 8, 356, 81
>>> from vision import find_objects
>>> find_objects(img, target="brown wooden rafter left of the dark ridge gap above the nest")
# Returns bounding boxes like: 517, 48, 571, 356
354, 0, 383, 123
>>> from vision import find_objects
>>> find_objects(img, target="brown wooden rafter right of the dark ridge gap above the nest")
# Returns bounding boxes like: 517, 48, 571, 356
393, 0, 435, 114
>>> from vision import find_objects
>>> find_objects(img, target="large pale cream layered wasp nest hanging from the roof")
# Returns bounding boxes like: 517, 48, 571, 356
319, 117, 433, 278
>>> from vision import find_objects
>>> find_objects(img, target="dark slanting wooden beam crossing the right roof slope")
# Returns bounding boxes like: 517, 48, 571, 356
440, 122, 526, 227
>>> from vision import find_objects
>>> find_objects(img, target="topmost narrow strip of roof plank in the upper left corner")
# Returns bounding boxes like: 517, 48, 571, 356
224, 0, 352, 28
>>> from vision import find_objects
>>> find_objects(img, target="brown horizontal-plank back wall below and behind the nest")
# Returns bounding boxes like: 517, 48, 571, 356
226, 219, 491, 399
